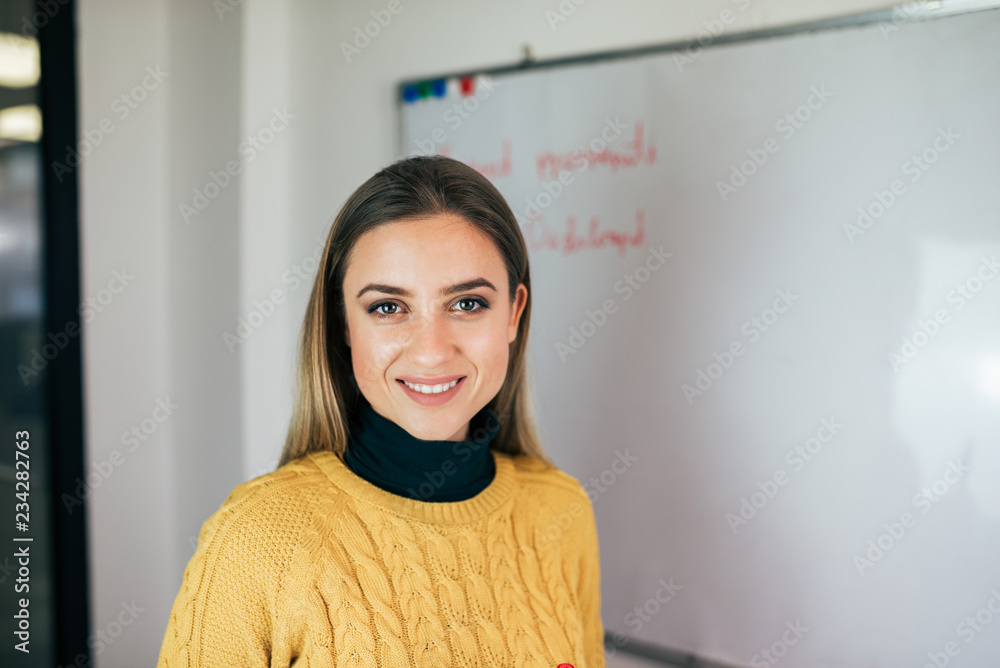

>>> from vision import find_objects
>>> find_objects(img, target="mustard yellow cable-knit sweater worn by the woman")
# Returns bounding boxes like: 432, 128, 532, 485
157, 451, 605, 668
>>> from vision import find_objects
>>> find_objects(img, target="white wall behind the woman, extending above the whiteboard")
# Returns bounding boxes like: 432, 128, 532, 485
78, 0, 890, 668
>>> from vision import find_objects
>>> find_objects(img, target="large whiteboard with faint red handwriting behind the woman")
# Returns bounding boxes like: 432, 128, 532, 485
401, 5, 1000, 668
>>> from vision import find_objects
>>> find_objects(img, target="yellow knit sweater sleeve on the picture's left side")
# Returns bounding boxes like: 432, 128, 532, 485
156, 483, 283, 668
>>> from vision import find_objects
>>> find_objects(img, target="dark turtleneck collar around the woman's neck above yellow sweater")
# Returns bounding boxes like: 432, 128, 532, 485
344, 395, 500, 502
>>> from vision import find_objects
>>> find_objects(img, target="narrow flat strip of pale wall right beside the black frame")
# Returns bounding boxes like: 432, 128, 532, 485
76, 1, 176, 666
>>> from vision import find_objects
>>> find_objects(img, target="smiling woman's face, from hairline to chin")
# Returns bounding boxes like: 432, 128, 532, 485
343, 214, 528, 441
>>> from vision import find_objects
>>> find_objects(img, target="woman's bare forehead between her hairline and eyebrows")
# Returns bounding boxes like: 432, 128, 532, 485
344, 214, 506, 288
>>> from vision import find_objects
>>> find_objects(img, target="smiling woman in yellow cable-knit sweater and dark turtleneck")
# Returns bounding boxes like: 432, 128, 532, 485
158, 156, 604, 668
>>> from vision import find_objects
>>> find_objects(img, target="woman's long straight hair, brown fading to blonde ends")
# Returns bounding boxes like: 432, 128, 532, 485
278, 156, 555, 467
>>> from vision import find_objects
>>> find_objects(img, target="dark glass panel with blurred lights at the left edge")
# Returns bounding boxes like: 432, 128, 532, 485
0, 0, 56, 666
